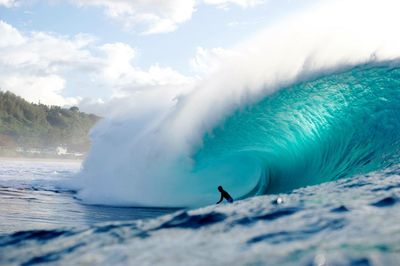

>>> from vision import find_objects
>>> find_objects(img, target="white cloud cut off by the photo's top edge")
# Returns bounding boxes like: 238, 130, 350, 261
0, 0, 265, 34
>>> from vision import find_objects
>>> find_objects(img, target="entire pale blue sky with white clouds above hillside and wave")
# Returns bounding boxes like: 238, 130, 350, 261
0, 0, 312, 115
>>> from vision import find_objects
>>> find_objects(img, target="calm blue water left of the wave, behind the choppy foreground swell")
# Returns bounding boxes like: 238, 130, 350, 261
0, 159, 174, 234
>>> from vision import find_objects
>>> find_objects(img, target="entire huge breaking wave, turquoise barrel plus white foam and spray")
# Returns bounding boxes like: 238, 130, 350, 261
73, 0, 400, 207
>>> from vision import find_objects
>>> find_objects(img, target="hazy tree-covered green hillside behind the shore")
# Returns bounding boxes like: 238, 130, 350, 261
0, 92, 100, 156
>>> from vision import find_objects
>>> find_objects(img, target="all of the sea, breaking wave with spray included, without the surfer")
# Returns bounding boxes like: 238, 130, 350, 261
0, 0, 400, 265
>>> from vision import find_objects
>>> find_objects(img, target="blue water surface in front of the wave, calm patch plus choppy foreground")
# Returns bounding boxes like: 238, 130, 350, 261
0, 161, 400, 265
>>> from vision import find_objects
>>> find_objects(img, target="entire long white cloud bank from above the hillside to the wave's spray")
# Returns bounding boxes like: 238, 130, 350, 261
0, 21, 193, 110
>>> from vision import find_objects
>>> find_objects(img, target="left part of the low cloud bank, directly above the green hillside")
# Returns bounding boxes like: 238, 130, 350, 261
0, 21, 99, 105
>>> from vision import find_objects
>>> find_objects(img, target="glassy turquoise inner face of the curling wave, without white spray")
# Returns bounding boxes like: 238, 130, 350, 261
192, 65, 400, 197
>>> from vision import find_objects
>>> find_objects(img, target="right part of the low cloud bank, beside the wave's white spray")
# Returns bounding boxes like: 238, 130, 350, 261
80, 43, 196, 116
